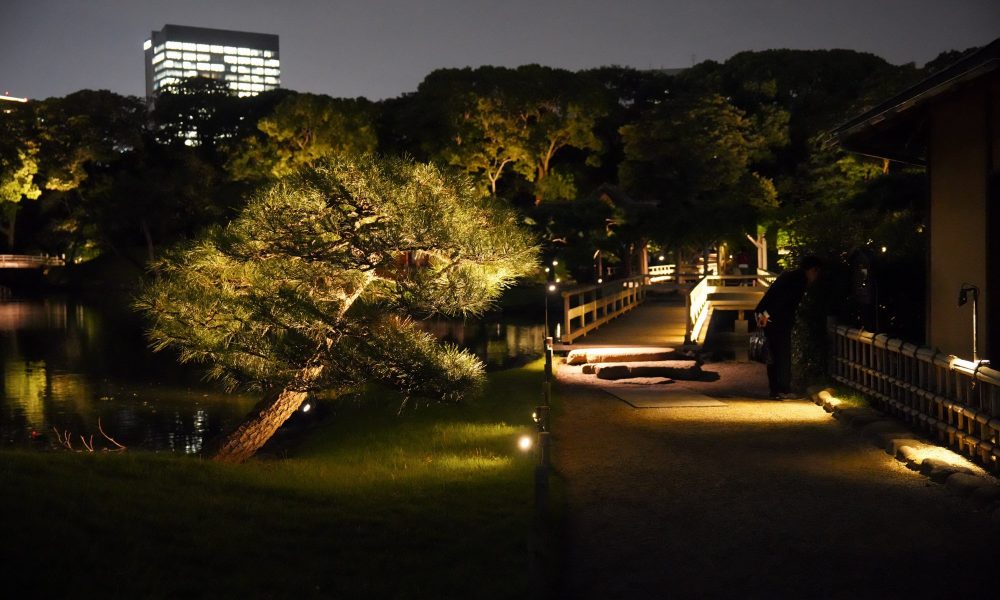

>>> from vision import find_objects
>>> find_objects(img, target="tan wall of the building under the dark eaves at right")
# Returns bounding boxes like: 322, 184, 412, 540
927, 85, 993, 360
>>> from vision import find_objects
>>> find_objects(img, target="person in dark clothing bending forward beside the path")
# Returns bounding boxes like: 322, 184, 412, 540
754, 256, 823, 400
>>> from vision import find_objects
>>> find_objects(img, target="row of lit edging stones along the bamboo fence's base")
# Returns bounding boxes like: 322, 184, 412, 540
809, 388, 1000, 527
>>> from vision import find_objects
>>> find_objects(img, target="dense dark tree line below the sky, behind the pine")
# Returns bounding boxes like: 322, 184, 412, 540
0, 50, 957, 322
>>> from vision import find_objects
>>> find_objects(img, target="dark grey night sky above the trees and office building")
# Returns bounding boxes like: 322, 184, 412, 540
0, 0, 1000, 99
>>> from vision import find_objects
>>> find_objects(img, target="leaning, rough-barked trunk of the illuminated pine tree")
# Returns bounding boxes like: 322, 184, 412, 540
207, 367, 322, 463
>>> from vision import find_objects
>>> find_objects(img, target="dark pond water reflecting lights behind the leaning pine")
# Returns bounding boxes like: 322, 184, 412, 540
0, 297, 543, 453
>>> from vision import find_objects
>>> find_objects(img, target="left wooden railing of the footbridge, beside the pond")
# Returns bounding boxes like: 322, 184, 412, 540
560, 275, 649, 343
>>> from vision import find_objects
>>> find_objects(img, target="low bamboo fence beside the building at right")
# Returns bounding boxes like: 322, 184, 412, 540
829, 325, 1000, 472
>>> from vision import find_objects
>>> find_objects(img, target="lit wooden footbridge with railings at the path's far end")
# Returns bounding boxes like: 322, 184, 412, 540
558, 265, 775, 348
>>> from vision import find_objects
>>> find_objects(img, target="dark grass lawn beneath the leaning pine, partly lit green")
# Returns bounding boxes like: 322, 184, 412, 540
0, 361, 551, 598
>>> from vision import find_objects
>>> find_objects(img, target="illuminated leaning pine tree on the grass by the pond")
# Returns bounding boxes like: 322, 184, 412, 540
137, 157, 536, 462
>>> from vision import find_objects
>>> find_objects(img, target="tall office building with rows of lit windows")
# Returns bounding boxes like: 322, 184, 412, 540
143, 25, 281, 98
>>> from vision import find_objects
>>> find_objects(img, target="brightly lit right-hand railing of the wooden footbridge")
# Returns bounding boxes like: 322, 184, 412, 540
685, 270, 777, 344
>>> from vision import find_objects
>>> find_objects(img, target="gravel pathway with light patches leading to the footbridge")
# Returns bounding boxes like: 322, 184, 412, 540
553, 364, 996, 599
